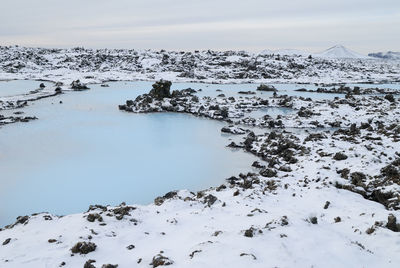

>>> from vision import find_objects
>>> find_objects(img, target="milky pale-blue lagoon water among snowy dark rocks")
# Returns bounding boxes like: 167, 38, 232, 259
0, 81, 400, 226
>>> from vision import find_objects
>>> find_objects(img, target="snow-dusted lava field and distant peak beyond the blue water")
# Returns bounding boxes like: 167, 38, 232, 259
0, 46, 400, 84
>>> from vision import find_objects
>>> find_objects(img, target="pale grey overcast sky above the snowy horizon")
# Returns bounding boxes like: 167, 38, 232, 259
0, 0, 400, 54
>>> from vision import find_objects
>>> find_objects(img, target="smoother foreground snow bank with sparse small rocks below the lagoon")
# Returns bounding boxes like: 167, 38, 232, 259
0, 181, 400, 268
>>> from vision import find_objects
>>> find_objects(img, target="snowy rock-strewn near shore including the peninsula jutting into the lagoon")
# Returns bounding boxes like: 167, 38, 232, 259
0, 80, 400, 268
